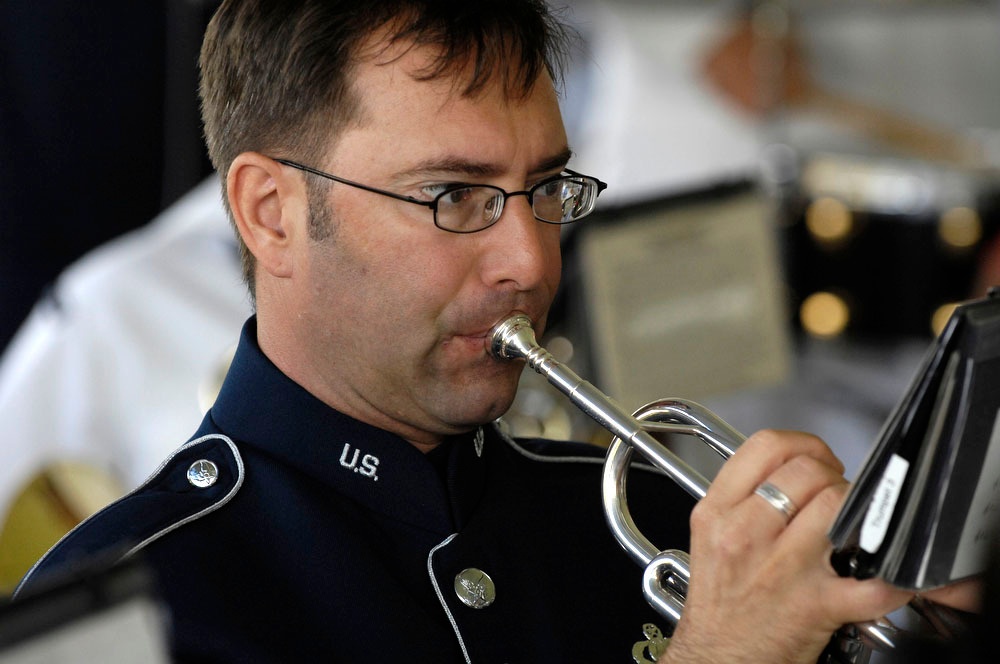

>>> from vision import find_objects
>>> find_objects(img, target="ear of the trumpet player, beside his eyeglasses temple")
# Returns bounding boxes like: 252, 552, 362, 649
226, 152, 309, 277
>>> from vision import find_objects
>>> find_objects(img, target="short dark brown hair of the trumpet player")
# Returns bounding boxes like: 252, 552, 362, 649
200, 0, 571, 296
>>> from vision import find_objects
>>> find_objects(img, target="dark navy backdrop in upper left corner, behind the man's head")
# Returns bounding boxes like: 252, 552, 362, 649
0, 0, 217, 345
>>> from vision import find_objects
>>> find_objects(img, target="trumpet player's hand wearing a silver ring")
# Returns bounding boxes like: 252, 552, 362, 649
660, 431, 911, 664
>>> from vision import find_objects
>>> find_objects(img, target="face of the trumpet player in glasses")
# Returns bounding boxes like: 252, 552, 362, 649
270, 41, 568, 447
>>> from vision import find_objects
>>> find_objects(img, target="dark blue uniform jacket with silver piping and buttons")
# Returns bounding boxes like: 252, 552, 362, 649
18, 319, 692, 664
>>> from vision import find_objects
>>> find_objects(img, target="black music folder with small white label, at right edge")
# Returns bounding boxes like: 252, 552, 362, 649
829, 288, 1000, 591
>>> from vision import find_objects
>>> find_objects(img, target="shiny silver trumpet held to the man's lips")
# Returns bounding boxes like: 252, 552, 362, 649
490, 314, 916, 664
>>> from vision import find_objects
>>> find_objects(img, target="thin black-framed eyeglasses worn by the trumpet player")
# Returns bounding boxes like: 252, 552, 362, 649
275, 159, 608, 233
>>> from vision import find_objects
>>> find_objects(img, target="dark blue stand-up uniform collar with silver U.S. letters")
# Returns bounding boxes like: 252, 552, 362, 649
209, 317, 492, 534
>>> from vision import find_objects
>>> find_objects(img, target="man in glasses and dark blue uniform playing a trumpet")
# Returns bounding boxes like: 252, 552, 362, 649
19, 0, 968, 663
